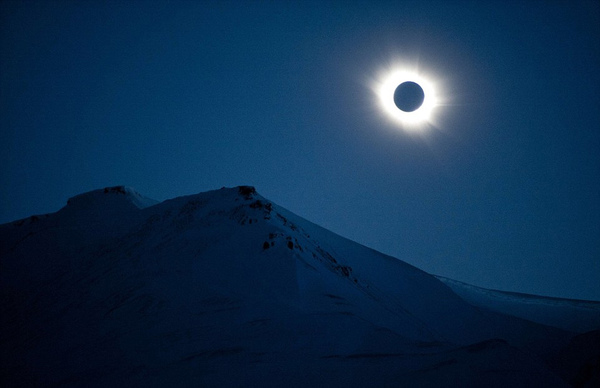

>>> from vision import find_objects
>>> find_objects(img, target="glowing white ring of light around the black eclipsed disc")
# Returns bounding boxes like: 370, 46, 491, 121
373, 68, 438, 130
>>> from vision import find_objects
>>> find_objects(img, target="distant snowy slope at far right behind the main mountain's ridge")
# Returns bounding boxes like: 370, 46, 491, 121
436, 276, 600, 333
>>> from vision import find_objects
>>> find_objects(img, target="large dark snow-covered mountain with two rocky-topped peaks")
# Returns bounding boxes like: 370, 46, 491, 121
0, 186, 600, 387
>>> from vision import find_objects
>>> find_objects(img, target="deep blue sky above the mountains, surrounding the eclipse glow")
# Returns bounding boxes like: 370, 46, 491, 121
0, 1, 600, 300
